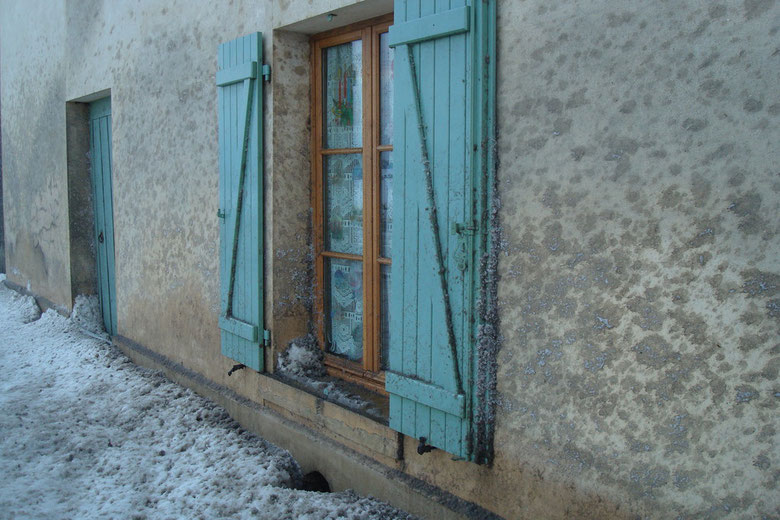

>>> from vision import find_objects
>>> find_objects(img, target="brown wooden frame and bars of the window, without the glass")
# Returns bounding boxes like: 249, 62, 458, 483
311, 14, 393, 395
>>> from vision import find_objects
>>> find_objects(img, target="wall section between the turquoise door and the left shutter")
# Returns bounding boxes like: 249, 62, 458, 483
58, 0, 272, 386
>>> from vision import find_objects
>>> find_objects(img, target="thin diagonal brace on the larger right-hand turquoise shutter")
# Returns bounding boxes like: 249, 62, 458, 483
406, 44, 464, 394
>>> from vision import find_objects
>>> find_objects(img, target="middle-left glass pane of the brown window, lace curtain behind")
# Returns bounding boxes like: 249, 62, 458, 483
323, 154, 363, 255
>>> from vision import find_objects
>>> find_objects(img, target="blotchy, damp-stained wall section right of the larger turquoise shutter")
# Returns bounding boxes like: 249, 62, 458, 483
496, 0, 780, 518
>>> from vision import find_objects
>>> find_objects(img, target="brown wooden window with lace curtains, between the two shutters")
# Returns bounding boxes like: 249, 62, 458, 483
312, 16, 393, 392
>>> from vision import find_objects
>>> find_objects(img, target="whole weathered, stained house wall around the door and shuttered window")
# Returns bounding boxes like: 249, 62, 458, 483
0, 0, 780, 519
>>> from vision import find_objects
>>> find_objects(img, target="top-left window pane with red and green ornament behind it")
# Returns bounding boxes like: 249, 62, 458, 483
322, 40, 363, 148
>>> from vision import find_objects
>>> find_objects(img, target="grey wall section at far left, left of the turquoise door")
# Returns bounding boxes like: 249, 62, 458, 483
0, 0, 71, 309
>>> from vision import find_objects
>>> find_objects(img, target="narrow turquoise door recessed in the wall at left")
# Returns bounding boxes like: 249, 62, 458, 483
89, 98, 116, 336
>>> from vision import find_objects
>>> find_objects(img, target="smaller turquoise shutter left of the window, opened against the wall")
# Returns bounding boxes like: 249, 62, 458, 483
217, 33, 264, 371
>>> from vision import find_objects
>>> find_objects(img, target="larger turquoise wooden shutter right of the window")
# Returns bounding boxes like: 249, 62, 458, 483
386, 0, 481, 459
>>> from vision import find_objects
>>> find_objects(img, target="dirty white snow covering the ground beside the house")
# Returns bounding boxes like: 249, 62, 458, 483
0, 282, 411, 520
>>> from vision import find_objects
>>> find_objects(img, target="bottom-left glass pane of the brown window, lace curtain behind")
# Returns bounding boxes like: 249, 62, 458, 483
325, 258, 363, 361
